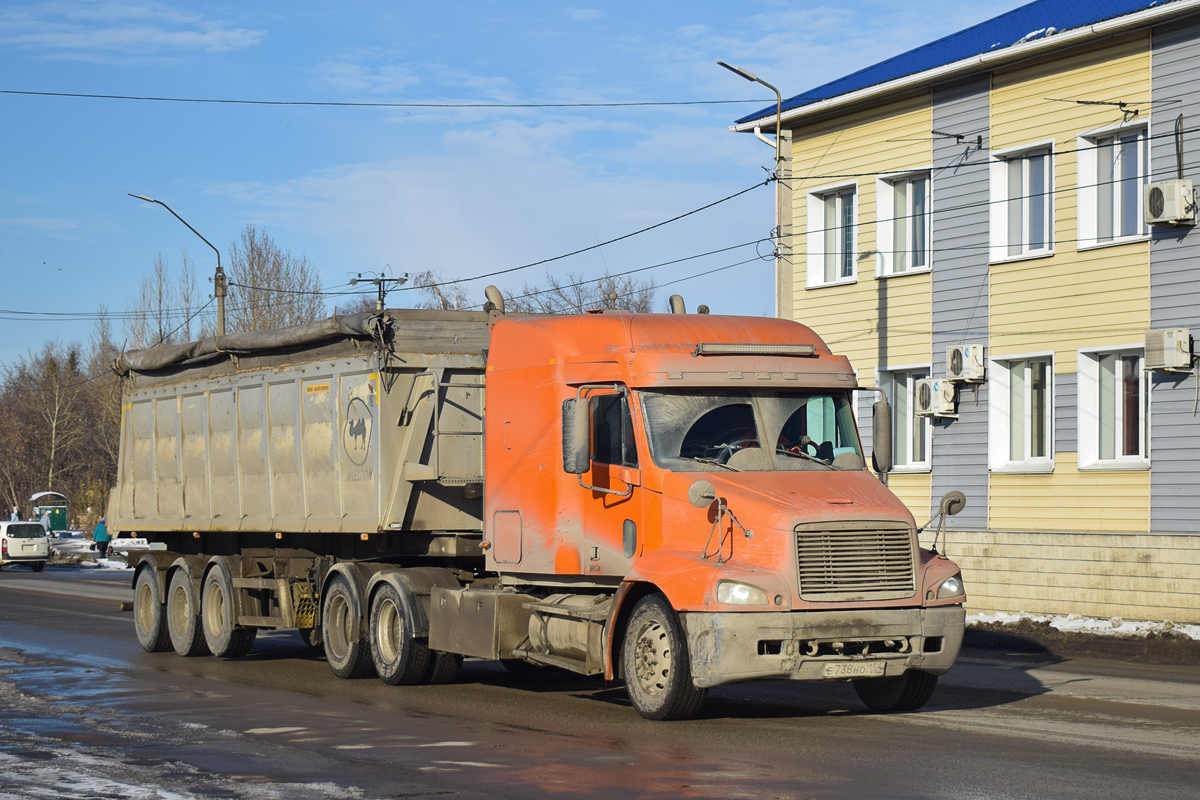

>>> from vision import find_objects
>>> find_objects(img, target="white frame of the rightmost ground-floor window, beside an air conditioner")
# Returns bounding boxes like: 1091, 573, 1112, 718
1078, 342, 1151, 470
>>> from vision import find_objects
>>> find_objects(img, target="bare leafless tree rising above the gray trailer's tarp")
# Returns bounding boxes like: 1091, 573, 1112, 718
226, 224, 325, 333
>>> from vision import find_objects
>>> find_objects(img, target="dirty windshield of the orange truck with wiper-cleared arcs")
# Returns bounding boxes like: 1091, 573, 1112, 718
638, 390, 864, 473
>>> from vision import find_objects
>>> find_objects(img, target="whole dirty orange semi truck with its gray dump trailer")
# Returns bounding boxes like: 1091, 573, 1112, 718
108, 303, 965, 720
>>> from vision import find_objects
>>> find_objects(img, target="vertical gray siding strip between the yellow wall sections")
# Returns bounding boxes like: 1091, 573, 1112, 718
930, 76, 990, 529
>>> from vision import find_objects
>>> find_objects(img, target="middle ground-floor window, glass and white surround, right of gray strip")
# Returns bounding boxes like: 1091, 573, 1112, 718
989, 356, 1054, 471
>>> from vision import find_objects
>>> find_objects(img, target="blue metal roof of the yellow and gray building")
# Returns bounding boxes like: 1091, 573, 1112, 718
737, 0, 1176, 125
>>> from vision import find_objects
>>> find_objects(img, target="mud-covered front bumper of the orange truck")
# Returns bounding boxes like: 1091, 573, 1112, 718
680, 606, 966, 687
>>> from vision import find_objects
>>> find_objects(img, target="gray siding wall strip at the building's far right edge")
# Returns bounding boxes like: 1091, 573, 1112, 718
1150, 18, 1200, 533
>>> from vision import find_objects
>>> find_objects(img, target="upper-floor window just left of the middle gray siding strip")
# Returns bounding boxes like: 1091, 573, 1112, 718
876, 172, 930, 275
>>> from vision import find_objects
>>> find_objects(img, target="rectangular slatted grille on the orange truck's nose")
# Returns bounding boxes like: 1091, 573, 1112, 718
796, 524, 914, 601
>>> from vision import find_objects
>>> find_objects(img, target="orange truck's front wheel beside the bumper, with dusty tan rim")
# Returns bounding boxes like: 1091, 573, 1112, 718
620, 595, 708, 720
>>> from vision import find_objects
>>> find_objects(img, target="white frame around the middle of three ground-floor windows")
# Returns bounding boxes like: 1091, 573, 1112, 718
988, 351, 1058, 473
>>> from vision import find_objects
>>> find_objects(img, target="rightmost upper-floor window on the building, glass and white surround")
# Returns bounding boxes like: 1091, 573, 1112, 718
1078, 126, 1150, 247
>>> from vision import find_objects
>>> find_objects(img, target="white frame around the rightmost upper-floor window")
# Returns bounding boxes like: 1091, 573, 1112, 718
1075, 120, 1150, 249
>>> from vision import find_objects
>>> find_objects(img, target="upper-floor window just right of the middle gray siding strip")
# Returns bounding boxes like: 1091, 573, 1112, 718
991, 149, 1054, 260
